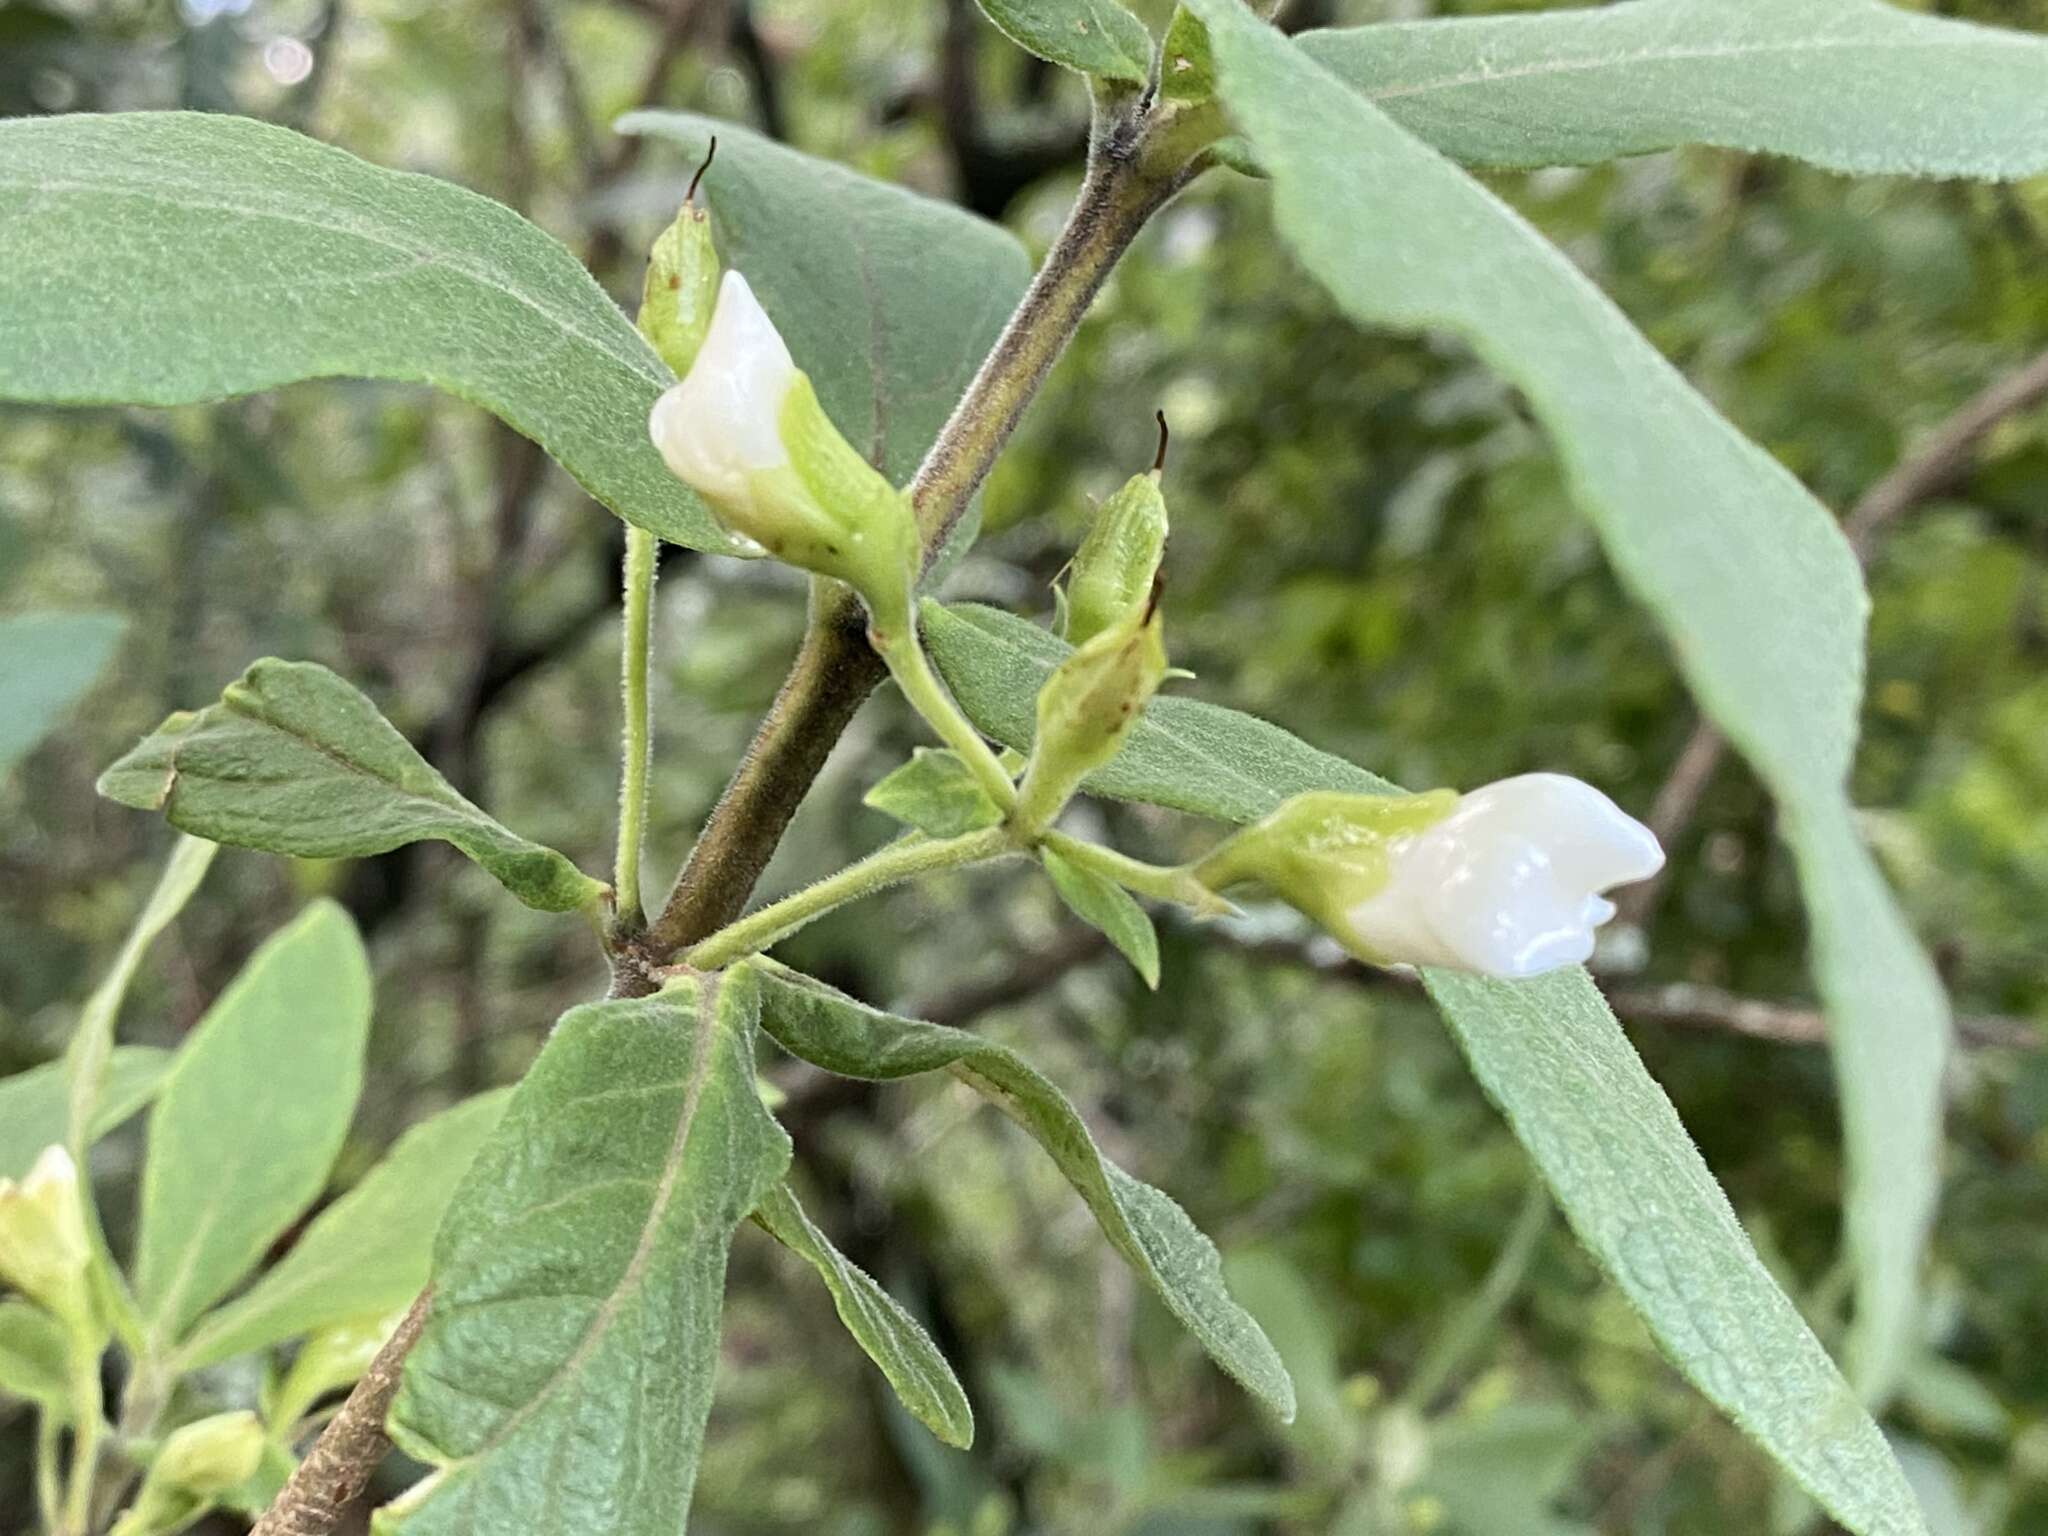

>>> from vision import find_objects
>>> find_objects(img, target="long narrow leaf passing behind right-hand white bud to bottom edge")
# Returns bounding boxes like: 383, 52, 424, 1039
924, 602, 1923, 1536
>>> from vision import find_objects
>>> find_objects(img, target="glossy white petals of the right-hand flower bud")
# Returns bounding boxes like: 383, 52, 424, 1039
1343, 774, 1663, 977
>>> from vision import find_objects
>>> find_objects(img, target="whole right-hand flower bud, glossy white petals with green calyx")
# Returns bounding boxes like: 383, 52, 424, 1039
1196, 774, 1663, 977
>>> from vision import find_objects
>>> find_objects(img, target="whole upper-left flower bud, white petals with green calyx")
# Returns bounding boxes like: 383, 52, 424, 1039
647, 272, 920, 627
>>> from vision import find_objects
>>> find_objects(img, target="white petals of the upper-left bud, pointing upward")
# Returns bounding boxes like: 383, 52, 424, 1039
647, 272, 797, 506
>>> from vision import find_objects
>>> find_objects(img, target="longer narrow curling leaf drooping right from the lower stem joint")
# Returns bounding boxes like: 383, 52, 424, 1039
752, 961, 1294, 1419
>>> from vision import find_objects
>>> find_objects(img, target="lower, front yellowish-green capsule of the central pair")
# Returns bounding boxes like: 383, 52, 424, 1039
1016, 586, 1165, 829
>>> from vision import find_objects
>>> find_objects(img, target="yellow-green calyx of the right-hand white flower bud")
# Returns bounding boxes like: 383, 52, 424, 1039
1194, 788, 1458, 937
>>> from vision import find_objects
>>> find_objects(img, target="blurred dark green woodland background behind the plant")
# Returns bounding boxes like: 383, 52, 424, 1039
0, 0, 2048, 1536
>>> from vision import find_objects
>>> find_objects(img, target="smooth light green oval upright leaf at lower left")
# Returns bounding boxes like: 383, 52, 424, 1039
135, 901, 371, 1352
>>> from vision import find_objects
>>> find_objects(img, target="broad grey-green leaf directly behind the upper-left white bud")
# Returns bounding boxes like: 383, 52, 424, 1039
616, 113, 1030, 485
